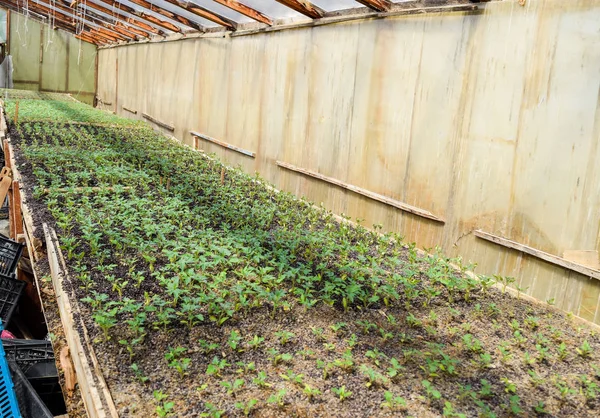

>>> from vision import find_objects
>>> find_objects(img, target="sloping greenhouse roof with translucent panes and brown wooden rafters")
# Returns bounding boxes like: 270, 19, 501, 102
0, 0, 482, 46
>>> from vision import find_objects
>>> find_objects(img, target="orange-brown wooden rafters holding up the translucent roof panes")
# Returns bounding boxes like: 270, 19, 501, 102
0, 0, 482, 45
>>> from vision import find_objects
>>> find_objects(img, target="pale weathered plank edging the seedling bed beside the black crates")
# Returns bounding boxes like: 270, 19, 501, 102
43, 223, 118, 418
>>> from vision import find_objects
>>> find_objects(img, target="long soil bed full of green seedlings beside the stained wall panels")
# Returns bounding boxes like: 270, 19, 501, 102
7, 96, 600, 417
